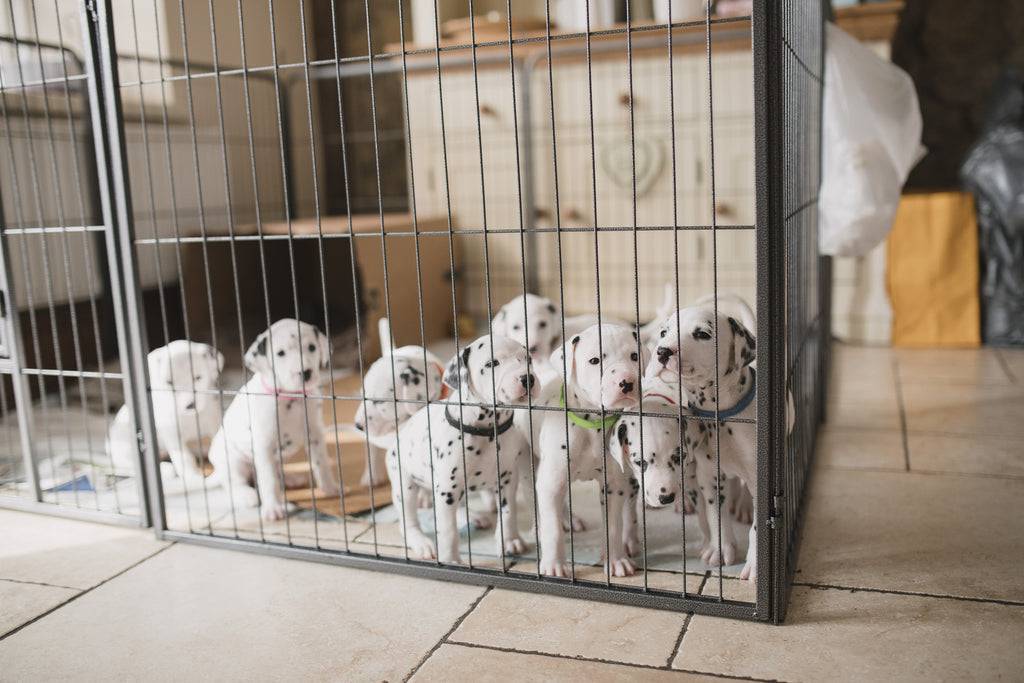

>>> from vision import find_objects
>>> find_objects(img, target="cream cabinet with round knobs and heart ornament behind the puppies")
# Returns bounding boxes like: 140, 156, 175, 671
407, 34, 756, 321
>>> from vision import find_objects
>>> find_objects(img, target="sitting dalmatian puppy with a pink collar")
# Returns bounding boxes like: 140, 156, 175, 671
210, 318, 341, 521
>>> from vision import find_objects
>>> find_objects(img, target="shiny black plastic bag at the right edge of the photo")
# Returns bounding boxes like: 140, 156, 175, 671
961, 68, 1024, 346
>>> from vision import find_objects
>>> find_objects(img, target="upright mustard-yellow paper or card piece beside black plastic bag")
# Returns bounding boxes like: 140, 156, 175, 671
886, 193, 981, 347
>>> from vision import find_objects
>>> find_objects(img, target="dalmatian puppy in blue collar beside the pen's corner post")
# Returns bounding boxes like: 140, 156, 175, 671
646, 305, 757, 582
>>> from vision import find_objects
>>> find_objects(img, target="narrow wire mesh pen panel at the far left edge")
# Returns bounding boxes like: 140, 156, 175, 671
0, 2, 146, 523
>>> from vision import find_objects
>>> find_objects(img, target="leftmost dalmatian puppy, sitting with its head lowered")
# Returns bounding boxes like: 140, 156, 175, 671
106, 339, 224, 486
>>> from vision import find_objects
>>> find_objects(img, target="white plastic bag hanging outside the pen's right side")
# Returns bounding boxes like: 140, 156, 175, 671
818, 24, 925, 256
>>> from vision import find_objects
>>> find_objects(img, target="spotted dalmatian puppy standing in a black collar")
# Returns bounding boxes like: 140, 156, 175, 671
385, 336, 539, 563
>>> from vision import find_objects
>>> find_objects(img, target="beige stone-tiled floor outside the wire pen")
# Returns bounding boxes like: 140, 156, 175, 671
0, 346, 1024, 681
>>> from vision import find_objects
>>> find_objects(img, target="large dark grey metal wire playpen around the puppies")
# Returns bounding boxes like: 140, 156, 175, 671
0, 0, 830, 622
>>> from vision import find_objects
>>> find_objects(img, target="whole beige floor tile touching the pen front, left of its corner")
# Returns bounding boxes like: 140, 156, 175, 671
450, 590, 684, 667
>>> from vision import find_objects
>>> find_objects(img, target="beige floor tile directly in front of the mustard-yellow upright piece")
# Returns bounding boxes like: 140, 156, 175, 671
894, 348, 1012, 384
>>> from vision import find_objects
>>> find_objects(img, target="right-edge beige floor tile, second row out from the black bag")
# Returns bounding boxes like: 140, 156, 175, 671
902, 381, 1024, 437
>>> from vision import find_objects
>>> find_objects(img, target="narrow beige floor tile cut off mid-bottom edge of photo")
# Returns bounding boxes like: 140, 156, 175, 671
410, 645, 711, 683
